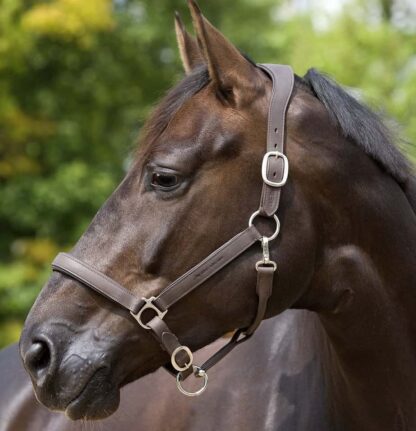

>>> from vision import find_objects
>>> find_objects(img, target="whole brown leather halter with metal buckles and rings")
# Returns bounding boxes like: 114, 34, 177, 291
52, 64, 294, 396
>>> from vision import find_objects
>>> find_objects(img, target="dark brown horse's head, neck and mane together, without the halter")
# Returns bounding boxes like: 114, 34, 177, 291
15, 2, 416, 431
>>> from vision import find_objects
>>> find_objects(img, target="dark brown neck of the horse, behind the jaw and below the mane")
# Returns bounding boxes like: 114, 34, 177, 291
297, 135, 416, 430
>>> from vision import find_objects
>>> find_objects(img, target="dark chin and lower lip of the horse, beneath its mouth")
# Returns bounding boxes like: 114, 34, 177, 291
65, 370, 120, 420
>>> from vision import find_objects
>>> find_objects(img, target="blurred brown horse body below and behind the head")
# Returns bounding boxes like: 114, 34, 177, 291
0, 310, 331, 431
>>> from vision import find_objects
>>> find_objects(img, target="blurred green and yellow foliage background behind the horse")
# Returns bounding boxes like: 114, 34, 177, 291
0, 0, 416, 347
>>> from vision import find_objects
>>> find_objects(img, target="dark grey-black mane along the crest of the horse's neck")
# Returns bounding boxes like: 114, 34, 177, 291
303, 69, 416, 211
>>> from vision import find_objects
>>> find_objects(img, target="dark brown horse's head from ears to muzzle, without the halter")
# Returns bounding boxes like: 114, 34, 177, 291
20, 1, 324, 419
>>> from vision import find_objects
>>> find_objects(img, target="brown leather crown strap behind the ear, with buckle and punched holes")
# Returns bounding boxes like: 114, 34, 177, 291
258, 64, 294, 217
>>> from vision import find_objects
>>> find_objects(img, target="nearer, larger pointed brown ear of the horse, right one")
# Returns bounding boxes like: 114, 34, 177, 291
188, 0, 259, 103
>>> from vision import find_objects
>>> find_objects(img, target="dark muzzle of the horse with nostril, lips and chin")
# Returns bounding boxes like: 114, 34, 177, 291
20, 323, 120, 420
